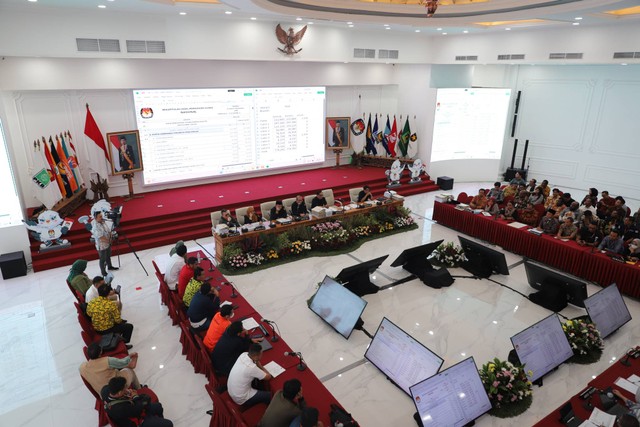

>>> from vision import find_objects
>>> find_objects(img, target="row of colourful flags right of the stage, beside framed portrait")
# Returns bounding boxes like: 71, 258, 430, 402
364, 113, 417, 157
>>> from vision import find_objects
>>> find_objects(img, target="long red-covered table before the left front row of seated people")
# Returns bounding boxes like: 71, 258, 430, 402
154, 251, 350, 426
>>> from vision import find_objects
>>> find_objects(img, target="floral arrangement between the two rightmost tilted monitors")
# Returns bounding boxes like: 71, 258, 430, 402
562, 316, 604, 365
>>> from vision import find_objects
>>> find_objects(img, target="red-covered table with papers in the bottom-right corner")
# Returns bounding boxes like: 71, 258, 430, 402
535, 350, 640, 427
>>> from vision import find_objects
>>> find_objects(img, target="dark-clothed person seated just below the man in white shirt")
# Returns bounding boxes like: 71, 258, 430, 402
258, 378, 304, 427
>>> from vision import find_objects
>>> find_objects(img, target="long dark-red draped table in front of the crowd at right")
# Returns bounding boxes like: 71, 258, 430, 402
433, 202, 640, 298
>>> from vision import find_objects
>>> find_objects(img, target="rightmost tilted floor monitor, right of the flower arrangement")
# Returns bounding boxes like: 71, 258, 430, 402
584, 283, 631, 338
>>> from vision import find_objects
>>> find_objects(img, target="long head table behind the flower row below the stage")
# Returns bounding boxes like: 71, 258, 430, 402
213, 199, 404, 262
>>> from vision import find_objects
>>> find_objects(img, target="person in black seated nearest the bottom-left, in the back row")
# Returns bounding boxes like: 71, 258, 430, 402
100, 377, 173, 427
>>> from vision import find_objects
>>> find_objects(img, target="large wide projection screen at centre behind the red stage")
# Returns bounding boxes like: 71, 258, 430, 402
133, 87, 326, 185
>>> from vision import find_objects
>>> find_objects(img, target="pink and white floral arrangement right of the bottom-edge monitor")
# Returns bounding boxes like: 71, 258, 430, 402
480, 357, 533, 418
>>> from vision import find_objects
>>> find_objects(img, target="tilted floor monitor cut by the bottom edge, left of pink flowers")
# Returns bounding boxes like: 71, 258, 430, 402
410, 357, 491, 427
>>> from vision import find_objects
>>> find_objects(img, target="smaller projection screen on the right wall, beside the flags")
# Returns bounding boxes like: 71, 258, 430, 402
429, 88, 511, 181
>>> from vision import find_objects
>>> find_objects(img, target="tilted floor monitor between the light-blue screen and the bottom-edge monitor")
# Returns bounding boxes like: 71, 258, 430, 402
364, 317, 444, 394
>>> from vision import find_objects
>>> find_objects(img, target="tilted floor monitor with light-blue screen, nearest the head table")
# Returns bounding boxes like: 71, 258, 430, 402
309, 276, 367, 339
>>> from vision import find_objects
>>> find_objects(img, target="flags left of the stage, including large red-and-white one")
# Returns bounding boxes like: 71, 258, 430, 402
31, 105, 109, 209
